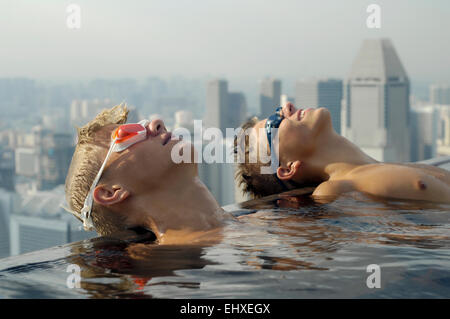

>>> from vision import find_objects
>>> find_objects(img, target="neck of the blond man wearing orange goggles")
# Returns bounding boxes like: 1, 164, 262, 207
133, 176, 226, 240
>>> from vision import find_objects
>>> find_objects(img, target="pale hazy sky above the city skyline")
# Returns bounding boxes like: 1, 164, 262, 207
0, 0, 450, 82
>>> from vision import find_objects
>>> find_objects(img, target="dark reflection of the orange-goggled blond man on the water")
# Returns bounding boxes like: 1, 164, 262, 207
66, 231, 218, 298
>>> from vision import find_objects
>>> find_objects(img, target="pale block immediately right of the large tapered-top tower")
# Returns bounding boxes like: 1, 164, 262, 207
411, 105, 439, 162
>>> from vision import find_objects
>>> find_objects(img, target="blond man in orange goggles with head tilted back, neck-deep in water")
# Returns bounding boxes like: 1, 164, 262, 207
65, 105, 228, 243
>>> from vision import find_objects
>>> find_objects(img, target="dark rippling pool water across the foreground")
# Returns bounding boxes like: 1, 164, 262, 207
0, 189, 450, 298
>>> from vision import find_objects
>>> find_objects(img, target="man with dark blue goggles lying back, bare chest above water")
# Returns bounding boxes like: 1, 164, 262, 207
235, 103, 450, 203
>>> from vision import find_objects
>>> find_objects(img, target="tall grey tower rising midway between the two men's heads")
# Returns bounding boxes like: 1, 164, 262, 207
204, 79, 231, 134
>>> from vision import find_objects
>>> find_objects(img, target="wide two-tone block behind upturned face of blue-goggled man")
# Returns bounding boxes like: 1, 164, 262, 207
295, 79, 342, 134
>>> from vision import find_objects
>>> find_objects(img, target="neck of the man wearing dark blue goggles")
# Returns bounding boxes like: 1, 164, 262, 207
307, 130, 378, 181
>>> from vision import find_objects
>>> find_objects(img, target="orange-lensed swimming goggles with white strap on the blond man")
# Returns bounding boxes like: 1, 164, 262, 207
80, 120, 150, 231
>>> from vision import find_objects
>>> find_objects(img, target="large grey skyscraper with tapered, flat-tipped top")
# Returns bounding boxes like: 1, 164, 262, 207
341, 39, 410, 162
